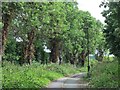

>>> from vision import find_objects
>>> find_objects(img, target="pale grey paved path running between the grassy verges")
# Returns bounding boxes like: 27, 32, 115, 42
47, 73, 88, 88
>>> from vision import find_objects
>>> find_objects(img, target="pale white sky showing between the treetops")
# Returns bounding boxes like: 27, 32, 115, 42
77, 0, 105, 23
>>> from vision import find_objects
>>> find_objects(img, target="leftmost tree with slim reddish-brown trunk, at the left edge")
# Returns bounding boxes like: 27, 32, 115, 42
2, 3, 18, 53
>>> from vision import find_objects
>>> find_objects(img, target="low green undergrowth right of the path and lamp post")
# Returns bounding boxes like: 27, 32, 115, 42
90, 60, 119, 88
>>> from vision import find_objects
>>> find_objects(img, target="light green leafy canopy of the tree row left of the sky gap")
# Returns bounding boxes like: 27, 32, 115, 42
2, 2, 104, 62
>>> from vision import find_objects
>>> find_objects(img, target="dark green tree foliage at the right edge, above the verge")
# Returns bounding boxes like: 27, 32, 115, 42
101, 2, 120, 57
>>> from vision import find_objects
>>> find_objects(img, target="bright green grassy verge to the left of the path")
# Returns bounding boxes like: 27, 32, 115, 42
2, 62, 80, 88
